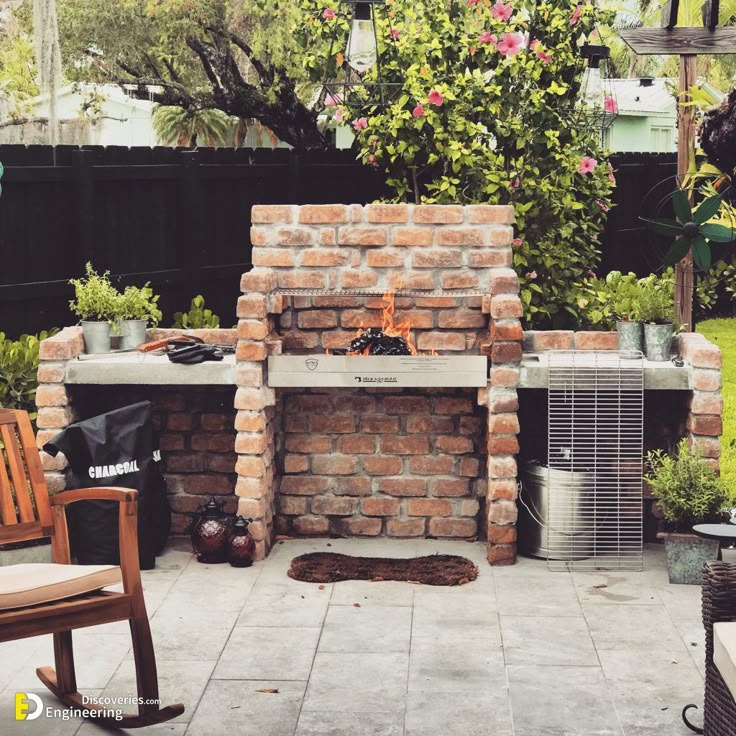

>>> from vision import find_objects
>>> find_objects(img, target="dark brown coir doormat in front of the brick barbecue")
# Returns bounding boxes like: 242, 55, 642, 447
288, 552, 478, 585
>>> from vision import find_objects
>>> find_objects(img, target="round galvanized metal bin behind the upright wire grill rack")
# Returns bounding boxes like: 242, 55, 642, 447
517, 461, 595, 560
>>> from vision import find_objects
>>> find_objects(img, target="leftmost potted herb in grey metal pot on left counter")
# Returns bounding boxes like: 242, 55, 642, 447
69, 263, 120, 353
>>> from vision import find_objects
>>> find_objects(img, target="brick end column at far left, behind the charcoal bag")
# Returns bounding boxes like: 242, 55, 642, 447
36, 327, 84, 493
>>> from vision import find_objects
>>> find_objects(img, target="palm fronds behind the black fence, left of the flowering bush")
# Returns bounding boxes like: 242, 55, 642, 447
153, 105, 235, 148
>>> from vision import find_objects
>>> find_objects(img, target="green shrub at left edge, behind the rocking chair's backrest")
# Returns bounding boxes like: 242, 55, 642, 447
0, 328, 59, 418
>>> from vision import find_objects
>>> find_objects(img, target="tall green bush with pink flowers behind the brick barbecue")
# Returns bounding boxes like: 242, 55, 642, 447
304, 0, 615, 329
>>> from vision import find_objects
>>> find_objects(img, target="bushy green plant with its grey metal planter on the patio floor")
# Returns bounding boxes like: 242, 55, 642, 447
644, 440, 729, 585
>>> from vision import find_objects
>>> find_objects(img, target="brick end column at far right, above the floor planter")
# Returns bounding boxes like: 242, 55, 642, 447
677, 332, 723, 470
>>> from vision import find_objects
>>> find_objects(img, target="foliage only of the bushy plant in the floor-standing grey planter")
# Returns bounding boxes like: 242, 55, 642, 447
644, 440, 729, 532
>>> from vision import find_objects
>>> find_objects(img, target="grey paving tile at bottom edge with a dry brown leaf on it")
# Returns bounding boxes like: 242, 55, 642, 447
186, 680, 306, 736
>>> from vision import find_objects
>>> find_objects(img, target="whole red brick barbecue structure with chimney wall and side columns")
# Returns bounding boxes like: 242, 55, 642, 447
37, 204, 722, 564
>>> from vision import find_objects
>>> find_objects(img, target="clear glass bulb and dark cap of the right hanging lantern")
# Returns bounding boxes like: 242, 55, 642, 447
570, 41, 618, 137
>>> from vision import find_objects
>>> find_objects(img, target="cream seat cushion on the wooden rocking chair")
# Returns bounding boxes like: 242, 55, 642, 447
0, 562, 121, 611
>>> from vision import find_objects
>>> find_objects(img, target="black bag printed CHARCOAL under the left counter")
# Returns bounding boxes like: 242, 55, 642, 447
43, 401, 171, 570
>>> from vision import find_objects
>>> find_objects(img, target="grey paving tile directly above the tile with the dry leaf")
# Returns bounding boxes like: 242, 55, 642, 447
213, 626, 320, 680
